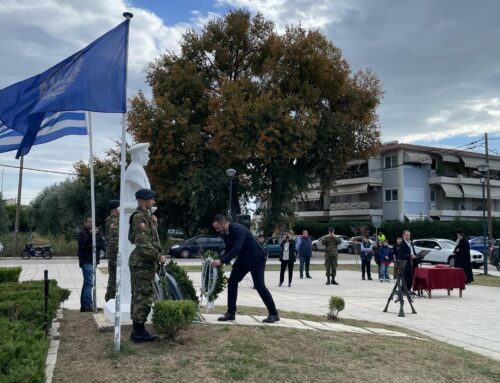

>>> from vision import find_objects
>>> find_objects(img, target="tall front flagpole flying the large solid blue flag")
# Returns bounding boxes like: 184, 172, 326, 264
114, 12, 134, 352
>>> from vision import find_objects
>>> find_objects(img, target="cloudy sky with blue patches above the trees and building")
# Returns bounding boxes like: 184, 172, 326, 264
0, 0, 500, 203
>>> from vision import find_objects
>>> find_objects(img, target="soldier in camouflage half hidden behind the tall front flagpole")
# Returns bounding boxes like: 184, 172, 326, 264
104, 199, 120, 302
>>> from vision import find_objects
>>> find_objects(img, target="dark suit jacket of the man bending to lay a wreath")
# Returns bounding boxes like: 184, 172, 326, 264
220, 223, 266, 268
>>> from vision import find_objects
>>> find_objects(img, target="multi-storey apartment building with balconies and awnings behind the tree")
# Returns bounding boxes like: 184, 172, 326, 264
295, 141, 500, 224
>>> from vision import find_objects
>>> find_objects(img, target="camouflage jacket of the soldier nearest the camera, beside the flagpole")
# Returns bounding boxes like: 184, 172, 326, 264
128, 208, 161, 266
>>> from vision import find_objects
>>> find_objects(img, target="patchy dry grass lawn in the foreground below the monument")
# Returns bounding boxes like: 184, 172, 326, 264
53, 308, 500, 383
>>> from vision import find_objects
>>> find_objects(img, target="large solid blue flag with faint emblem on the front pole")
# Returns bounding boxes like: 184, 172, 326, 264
0, 20, 130, 158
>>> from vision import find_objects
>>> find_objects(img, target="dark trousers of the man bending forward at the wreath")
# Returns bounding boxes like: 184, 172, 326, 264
227, 258, 278, 315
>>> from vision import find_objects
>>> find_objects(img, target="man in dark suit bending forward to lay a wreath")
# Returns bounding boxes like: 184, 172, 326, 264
212, 215, 280, 323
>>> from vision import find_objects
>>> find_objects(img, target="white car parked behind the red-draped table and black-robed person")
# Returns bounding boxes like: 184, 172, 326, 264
413, 238, 484, 269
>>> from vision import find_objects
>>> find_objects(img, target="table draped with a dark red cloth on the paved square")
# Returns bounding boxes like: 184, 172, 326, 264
413, 266, 466, 299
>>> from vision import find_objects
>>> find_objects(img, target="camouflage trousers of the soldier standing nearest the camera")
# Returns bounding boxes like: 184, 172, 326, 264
130, 266, 155, 323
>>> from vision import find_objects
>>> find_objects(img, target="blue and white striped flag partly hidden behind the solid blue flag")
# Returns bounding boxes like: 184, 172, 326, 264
0, 112, 87, 153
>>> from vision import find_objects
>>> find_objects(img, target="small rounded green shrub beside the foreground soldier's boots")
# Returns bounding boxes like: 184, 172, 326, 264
153, 300, 197, 340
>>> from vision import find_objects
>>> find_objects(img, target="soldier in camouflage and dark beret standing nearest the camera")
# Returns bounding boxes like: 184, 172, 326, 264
128, 189, 166, 342
